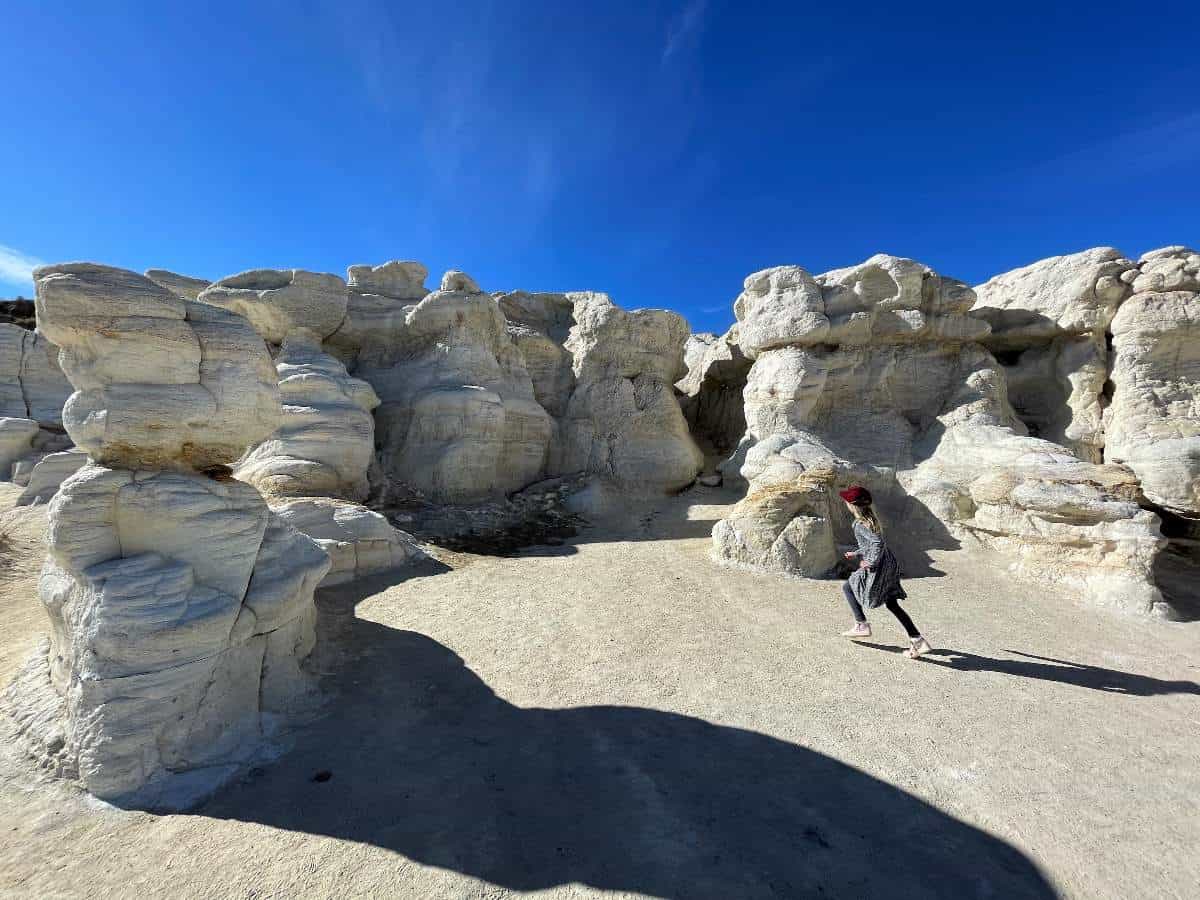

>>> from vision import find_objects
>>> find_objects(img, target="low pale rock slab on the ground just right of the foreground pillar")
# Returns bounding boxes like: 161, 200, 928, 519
271, 497, 426, 587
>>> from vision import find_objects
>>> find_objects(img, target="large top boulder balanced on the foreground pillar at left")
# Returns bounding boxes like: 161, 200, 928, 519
34, 263, 280, 470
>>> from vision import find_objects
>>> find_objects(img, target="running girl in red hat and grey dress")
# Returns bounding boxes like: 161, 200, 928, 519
838, 485, 934, 659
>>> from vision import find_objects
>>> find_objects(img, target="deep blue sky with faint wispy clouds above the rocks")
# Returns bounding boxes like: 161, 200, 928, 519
0, 0, 1200, 330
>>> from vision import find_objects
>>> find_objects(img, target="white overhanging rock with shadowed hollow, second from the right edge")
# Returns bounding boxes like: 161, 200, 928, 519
972, 247, 1139, 462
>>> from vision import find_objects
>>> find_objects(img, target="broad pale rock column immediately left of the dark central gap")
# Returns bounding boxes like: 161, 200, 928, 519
548, 293, 704, 493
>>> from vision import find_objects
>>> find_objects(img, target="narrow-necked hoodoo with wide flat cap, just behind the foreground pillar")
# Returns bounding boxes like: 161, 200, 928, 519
199, 269, 379, 500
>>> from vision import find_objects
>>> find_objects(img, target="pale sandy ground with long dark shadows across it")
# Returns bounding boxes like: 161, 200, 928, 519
0, 488, 1200, 899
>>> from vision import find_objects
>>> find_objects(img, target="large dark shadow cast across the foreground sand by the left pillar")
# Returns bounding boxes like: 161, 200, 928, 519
196, 578, 1055, 900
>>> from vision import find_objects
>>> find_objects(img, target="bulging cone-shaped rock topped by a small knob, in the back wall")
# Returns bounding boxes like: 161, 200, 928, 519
355, 271, 553, 503
